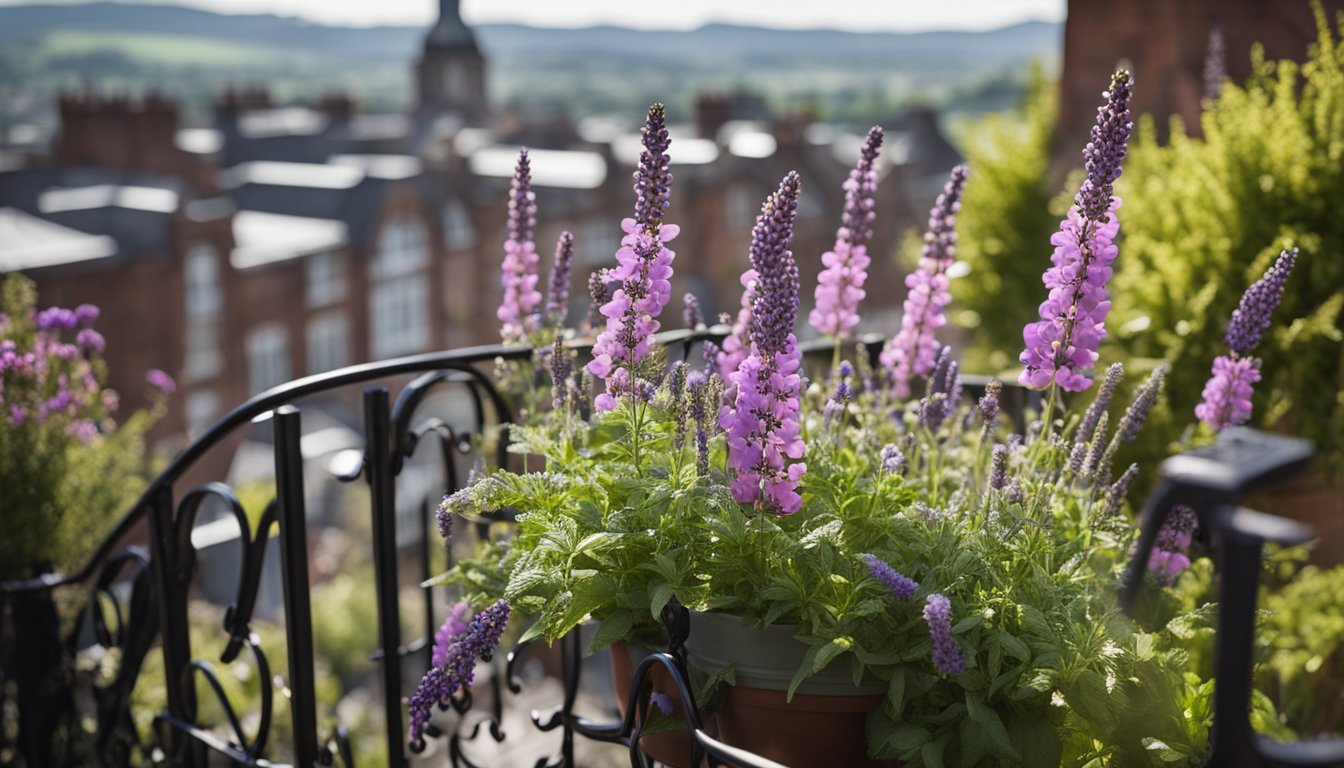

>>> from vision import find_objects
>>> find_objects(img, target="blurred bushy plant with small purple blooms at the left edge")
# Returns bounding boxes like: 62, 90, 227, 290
0, 274, 171, 578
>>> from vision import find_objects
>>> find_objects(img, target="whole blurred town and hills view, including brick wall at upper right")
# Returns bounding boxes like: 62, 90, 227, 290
0, 0, 1312, 462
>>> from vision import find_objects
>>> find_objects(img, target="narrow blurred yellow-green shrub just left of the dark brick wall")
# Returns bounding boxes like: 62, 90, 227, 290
952, 66, 1063, 371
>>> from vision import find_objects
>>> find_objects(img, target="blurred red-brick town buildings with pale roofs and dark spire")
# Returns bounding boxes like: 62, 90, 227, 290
0, 0, 960, 462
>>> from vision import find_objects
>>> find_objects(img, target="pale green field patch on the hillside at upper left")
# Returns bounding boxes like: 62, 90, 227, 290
40, 30, 305, 69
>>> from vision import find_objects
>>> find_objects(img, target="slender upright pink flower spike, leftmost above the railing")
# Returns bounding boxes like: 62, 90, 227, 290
496, 149, 542, 342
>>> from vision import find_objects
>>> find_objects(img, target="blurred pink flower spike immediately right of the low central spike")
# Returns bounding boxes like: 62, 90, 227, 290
808, 126, 882, 339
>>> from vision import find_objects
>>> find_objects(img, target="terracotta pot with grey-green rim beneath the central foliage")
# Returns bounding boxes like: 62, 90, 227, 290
687, 613, 899, 768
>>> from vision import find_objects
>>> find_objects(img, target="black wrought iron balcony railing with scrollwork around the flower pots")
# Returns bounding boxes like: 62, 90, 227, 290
0, 327, 1344, 768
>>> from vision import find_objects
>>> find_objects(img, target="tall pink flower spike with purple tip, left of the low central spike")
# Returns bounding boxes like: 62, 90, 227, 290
587, 104, 680, 410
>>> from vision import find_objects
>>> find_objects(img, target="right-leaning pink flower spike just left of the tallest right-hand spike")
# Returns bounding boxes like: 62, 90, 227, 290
882, 165, 966, 397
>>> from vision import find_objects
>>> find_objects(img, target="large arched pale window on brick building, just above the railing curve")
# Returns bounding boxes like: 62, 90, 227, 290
368, 217, 430, 359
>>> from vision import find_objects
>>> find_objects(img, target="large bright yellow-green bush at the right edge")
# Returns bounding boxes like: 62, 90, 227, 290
1111, 8, 1344, 472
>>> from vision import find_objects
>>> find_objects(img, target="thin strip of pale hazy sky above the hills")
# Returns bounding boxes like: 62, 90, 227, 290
0, 0, 1066, 31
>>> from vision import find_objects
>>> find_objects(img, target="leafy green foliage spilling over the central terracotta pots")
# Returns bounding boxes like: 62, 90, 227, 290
435, 349, 1211, 767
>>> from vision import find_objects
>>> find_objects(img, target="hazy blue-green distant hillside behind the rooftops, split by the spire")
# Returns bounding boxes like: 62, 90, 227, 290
0, 3, 1060, 122
